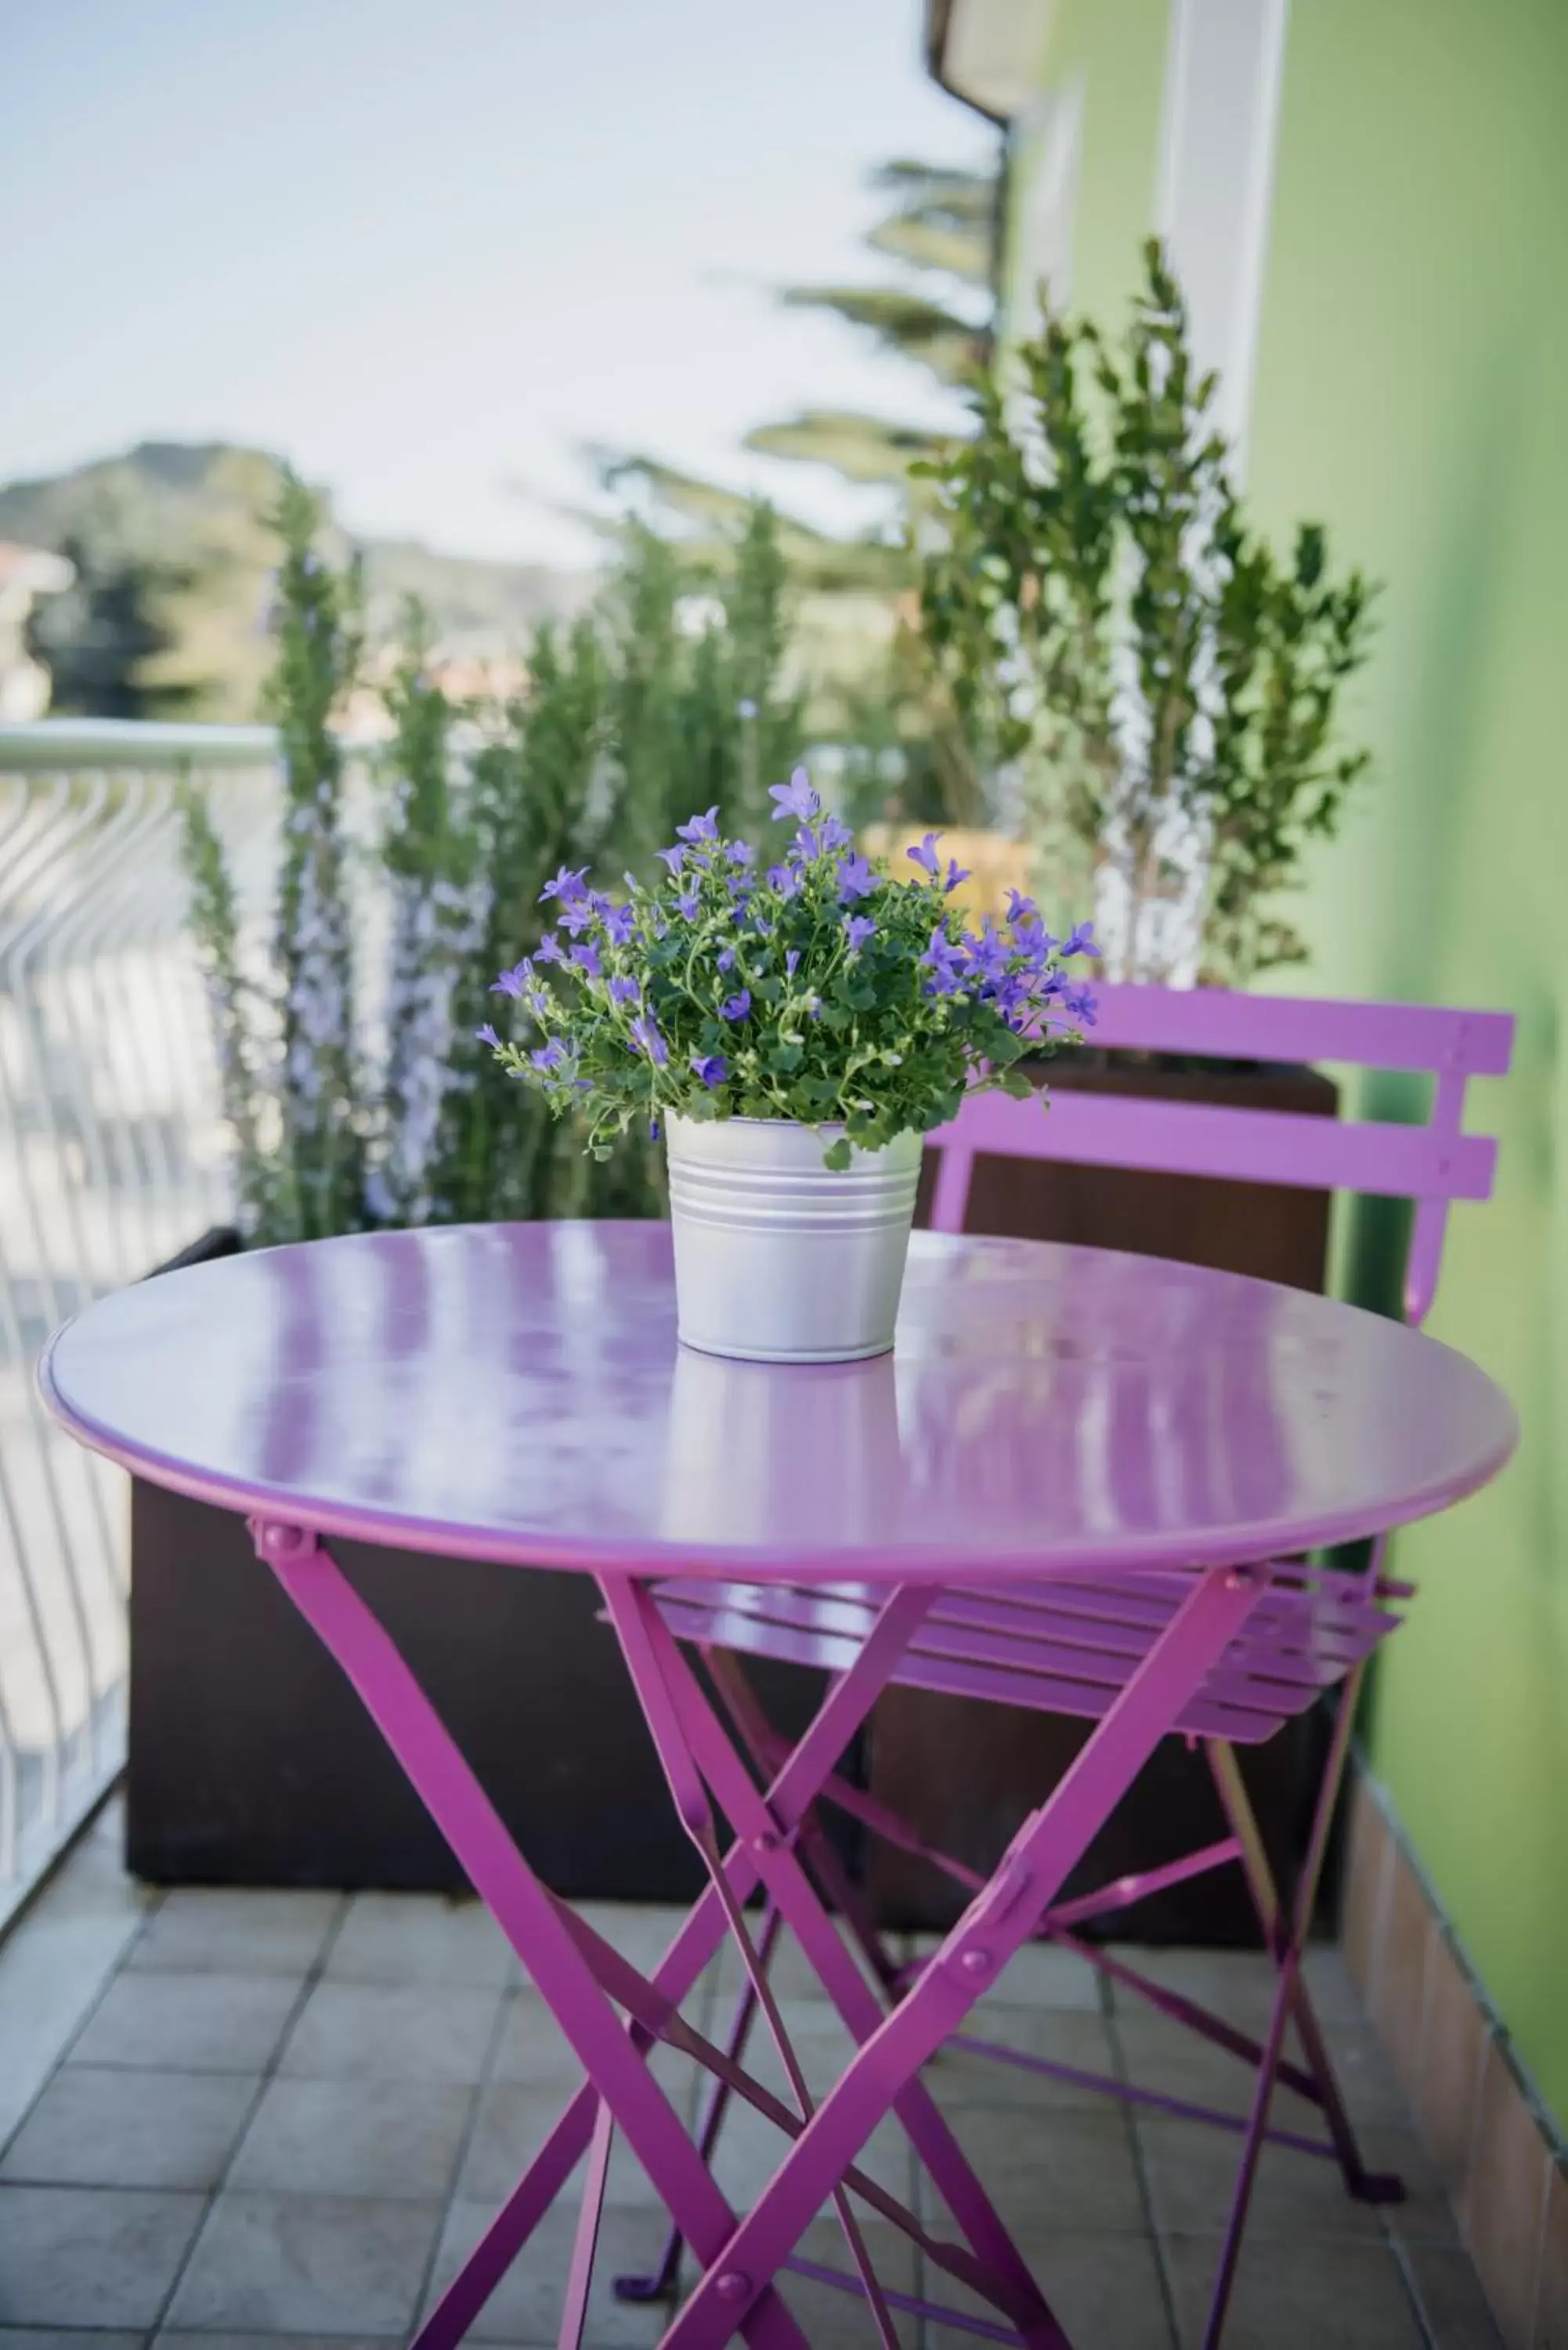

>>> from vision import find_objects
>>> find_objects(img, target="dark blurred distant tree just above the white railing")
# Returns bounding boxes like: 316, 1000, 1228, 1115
26, 533, 200, 719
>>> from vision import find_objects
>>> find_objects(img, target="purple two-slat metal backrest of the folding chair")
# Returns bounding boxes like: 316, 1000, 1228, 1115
929, 987, 1514, 1321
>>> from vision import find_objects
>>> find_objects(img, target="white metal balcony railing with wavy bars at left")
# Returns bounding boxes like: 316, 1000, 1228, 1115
0, 719, 280, 1925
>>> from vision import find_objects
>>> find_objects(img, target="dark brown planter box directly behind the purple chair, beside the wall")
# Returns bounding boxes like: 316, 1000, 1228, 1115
868, 1053, 1338, 1943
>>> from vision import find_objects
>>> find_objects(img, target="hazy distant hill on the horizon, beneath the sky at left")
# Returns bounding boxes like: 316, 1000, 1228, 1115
0, 442, 592, 719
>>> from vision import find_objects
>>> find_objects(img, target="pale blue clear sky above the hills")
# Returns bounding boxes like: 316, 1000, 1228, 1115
0, 0, 992, 562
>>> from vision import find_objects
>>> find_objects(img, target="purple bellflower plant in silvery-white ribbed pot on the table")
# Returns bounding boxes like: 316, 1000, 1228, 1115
482, 768, 1096, 1363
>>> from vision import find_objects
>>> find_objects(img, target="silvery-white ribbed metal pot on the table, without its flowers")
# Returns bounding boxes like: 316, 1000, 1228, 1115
667, 1116, 922, 1363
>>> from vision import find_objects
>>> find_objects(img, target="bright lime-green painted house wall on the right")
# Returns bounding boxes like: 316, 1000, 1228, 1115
1018, 0, 1568, 2124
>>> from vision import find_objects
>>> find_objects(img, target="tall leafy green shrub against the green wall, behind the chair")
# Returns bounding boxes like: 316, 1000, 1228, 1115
917, 242, 1373, 982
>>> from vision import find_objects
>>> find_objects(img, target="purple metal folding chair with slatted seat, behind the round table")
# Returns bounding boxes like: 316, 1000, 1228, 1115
644, 987, 1514, 2350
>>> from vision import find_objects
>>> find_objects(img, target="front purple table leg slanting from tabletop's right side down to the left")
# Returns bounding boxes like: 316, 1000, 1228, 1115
660, 1570, 1267, 2350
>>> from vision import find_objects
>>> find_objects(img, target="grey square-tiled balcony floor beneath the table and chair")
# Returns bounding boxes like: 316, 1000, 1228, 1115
0, 1817, 1498, 2350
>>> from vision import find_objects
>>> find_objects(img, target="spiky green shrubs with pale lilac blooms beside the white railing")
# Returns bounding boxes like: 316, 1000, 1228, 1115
183, 477, 802, 1241
